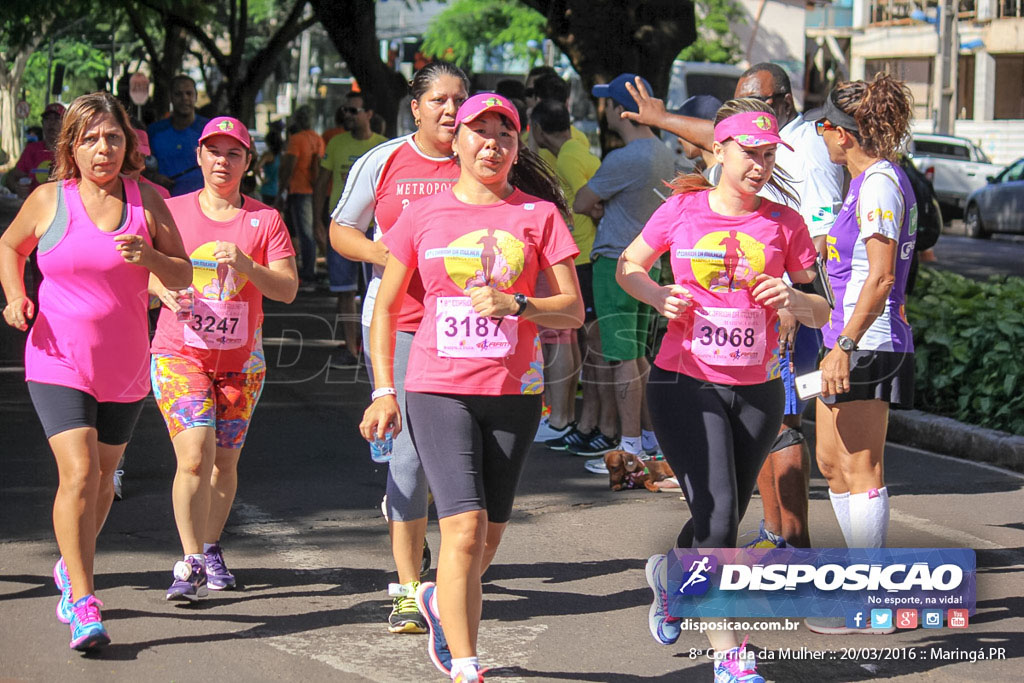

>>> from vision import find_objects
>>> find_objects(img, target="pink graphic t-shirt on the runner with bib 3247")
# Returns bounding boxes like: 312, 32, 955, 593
151, 190, 295, 373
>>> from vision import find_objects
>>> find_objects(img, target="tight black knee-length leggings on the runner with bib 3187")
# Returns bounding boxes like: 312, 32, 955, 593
406, 391, 542, 523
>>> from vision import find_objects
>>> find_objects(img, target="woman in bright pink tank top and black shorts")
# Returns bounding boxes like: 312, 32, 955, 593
0, 92, 191, 650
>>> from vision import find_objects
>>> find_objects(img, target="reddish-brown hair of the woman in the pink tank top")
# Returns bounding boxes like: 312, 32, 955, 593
52, 92, 145, 180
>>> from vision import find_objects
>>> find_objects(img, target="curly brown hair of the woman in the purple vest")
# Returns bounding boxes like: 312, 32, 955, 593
834, 73, 913, 161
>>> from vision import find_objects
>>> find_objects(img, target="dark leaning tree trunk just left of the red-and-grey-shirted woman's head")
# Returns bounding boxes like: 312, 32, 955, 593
309, 0, 409, 137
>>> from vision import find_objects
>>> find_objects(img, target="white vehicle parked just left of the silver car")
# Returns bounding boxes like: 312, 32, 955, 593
907, 133, 1001, 209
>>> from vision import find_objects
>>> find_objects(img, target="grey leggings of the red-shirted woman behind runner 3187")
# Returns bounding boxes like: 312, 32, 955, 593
362, 327, 427, 522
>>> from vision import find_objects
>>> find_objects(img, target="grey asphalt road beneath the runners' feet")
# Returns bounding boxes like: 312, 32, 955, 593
0, 296, 1024, 682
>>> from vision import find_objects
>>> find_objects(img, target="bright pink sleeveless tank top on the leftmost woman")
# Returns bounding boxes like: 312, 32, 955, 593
25, 178, 152, 403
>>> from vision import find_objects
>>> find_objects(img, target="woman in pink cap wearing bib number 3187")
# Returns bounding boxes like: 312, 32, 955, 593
359, 93, 584, 683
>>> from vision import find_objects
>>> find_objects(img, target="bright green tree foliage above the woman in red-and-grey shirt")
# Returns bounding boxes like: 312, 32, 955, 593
421, 0, 545, 67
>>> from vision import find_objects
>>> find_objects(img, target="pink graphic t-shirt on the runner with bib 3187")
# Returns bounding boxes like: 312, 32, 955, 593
383, 189, 580, 395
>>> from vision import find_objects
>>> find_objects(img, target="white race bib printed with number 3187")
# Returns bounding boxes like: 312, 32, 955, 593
436, 297, 519, 358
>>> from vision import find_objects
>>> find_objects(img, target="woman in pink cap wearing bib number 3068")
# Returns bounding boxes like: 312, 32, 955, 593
616, 99, 828, 683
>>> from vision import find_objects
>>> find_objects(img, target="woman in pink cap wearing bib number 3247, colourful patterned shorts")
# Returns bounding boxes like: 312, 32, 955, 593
151, 117, 299, 600
